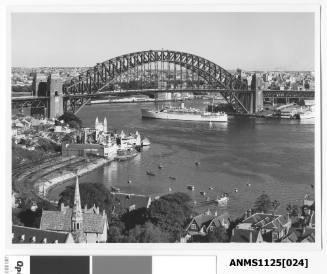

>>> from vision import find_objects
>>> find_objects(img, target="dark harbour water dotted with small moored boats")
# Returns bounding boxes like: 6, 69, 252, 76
50, 101, 314, 217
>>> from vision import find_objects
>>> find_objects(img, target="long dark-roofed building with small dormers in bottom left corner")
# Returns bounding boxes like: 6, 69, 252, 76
12, 225, 74, 244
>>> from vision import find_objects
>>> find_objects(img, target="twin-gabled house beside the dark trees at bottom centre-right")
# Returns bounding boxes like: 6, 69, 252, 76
186, 212, 230, 236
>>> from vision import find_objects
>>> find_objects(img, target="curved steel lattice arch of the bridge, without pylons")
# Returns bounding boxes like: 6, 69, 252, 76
63, 50, 250, 113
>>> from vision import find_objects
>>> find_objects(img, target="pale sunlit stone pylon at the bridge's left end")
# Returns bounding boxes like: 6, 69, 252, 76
48, 74, 64, 118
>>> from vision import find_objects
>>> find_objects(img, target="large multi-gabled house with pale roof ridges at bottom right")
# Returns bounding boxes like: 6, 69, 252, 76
231, 213, 291, 242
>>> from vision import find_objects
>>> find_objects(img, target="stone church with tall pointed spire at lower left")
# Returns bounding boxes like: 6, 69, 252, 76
40, 177, 108, 243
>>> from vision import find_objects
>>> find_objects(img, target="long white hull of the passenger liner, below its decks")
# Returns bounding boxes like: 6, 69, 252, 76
141, 109, 227, 122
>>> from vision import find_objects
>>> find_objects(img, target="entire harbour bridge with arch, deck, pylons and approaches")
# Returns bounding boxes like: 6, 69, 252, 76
12, 50, 314, 117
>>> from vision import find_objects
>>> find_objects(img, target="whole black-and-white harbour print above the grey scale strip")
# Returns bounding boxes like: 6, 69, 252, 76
8, 10, 321, 244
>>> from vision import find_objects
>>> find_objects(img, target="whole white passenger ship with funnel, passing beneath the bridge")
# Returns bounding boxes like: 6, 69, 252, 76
141, 103, 228, 122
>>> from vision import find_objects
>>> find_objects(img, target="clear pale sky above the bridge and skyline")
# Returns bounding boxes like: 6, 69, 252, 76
11, 12, 315, 71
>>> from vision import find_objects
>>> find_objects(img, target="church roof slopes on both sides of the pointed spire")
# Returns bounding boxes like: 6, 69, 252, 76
40, 208, 107, 233
